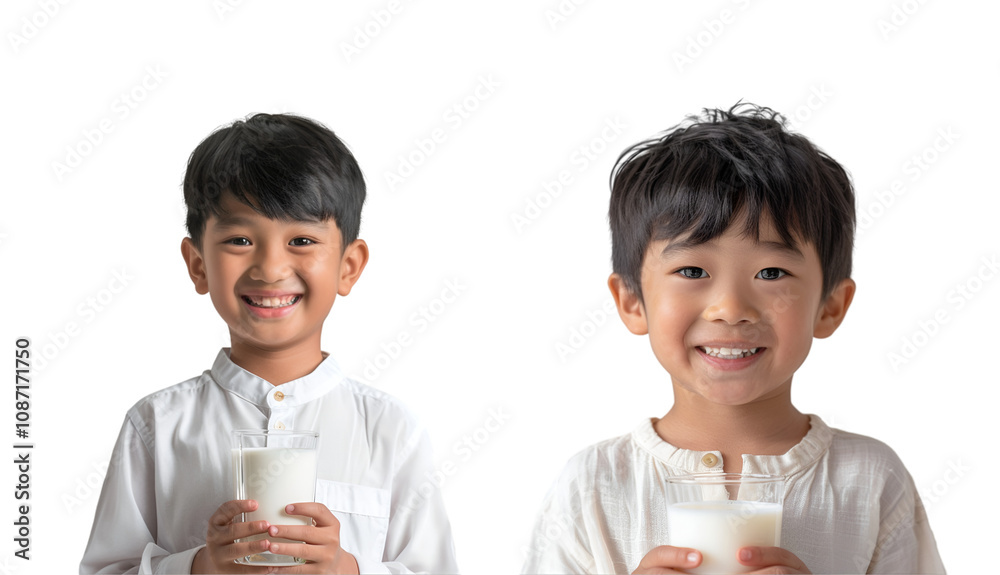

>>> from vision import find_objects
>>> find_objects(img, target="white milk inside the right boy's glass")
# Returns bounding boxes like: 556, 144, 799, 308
667, 501, 781, 573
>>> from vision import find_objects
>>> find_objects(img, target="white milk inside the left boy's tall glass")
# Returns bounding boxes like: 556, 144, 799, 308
233, 447, 316, 564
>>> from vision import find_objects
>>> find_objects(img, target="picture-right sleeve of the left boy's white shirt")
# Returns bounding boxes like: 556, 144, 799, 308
370, 430, 458, 573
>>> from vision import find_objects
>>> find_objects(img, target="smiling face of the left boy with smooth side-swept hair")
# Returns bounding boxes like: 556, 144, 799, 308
181, 194, 368, 360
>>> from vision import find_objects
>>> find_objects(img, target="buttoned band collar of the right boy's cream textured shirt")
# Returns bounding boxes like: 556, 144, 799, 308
632, 414, 833, 477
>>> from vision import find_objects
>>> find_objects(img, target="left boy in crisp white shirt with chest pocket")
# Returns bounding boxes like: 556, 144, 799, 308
80, 114, 457, 573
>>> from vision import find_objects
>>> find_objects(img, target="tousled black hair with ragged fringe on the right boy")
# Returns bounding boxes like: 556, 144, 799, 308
608, 102, 855, 301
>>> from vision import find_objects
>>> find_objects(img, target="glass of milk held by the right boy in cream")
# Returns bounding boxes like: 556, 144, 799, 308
667, 473, 785, 573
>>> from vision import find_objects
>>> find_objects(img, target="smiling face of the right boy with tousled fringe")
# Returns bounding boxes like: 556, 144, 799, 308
609, 214, 854, 405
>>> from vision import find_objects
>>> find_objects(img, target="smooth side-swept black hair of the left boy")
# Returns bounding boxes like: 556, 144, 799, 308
184, 114, 365, 249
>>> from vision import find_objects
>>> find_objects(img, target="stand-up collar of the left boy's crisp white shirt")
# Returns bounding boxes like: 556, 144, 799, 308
211, 347, 345, 409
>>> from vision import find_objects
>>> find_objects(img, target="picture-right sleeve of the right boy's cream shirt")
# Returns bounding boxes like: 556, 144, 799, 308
868, 466, 945, 574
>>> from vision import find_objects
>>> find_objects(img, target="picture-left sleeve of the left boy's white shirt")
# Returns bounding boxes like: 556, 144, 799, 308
80, 417, 200, 575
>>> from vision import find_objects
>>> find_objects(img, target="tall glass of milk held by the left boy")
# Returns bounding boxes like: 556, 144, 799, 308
233, 429, 319, 567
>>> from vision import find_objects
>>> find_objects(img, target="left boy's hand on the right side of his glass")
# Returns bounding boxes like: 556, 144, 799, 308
268, 503, 358, 574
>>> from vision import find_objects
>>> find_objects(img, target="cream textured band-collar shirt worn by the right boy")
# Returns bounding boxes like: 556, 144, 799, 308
523, 415, 944, 573
